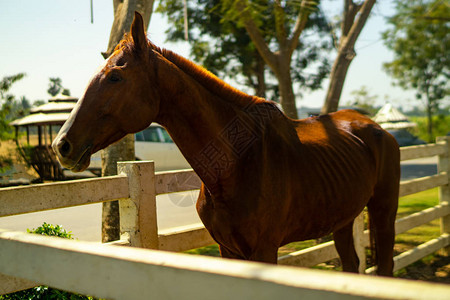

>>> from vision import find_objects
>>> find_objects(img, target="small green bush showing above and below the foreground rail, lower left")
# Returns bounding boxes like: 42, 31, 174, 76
0, 222, 95, 300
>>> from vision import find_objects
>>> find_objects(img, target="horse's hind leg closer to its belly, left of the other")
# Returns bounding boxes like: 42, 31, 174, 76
333, 220, 359, 273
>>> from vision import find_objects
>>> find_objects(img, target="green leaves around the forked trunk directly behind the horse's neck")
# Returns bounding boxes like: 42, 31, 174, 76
157, 0, 332, 99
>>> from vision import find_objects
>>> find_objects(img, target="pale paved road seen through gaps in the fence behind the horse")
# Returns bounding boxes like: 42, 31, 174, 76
0, 158, 437, 241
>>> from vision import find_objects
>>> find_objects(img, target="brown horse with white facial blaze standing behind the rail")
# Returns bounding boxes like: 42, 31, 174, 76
53, 14, 400, 275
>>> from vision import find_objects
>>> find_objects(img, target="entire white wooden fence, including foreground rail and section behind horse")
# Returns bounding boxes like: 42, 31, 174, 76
0, 137, 450, 299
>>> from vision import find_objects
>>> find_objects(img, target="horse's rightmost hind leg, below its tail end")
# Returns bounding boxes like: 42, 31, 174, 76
367, 191, 398, 276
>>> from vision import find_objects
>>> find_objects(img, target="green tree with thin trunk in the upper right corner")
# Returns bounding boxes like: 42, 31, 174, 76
383, 0, 450, 141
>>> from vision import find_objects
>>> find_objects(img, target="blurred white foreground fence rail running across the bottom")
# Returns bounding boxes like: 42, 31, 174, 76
0, 231, 450, 300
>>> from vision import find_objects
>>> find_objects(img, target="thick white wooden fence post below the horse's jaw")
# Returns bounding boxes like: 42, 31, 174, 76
117, 161, 159, 249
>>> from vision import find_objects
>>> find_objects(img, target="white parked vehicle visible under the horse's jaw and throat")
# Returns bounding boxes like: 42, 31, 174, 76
89, 124, 191, 171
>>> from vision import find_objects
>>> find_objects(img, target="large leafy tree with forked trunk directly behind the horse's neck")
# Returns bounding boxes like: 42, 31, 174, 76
158, 0, 332, 116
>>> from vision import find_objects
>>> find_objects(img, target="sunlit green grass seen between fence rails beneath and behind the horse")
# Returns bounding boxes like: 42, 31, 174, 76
186, 188, 440, 269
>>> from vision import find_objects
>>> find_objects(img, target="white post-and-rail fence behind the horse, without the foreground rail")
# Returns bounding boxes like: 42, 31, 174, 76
0, 137, 450, 293
